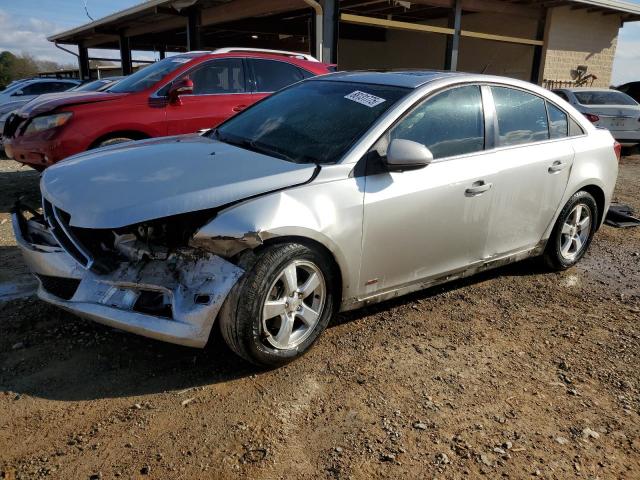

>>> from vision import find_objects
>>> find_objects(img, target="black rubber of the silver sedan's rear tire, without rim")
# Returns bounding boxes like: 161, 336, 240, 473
543, 191, 599, 271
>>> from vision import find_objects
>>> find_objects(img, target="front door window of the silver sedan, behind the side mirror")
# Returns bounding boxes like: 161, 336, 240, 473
389, 85, 484, 159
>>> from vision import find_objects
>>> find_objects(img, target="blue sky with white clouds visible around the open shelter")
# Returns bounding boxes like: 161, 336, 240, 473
0, 0, 640, 85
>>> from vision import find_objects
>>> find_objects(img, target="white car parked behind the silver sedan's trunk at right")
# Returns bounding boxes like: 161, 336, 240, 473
553, 88, 640, 147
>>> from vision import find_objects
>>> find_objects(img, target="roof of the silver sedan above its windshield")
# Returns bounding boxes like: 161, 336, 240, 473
311, 70, 469, 88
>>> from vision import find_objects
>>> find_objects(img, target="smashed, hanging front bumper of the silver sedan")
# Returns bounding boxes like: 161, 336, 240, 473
12, 208, 243, 348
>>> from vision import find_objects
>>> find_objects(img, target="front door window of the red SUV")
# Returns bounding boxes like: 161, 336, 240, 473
187, 58, 245, 95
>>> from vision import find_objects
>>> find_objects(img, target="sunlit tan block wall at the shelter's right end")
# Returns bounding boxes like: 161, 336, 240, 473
541, 7, 620, 87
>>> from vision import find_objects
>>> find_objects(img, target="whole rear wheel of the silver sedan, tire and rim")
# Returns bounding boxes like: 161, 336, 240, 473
544, 191, 598, 270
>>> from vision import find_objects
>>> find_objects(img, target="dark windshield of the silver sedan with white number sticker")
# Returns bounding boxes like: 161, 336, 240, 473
213, 80, 409, 163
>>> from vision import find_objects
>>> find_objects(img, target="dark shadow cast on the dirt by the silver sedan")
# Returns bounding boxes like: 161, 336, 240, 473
0, 253, 544, 401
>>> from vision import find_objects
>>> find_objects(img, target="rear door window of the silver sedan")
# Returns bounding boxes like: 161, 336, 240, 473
491, 87, 549, 147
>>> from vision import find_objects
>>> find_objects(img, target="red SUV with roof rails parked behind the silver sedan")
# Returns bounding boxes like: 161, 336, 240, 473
3, 48, 333, 170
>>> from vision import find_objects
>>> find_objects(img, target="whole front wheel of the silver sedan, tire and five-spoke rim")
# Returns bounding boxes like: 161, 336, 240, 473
219, 243, 334, 366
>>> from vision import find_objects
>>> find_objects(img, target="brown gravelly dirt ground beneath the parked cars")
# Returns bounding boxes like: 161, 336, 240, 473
0, 156, 640, 479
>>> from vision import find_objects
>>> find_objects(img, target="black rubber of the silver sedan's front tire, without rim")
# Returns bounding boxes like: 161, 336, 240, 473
218, 243, 334, 367
